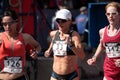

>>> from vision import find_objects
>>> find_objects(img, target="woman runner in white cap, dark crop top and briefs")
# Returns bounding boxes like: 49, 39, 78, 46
45, 9, 85, 80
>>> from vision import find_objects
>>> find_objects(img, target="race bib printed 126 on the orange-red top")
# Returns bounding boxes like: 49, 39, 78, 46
3, 57, 22, 73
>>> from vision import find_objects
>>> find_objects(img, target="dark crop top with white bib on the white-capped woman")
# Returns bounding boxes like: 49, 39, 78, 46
52, 30, 75, 56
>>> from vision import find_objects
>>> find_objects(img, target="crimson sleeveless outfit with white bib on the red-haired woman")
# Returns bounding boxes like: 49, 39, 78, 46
102, 27, 120, 77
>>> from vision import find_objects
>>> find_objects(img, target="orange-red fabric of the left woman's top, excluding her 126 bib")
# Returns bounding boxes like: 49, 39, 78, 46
0, 33, 25, 69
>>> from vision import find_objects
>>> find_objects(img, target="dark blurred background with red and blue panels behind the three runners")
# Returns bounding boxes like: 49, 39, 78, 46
0, 0, 120, 80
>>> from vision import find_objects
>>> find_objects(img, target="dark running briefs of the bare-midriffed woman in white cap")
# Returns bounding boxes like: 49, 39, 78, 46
52, 71, 78, 80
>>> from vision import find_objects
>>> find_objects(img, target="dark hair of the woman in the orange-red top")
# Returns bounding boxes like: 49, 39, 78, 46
2, 10, 18, 20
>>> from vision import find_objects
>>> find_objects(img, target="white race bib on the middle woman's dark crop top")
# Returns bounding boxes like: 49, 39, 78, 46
53, 41, 67, 56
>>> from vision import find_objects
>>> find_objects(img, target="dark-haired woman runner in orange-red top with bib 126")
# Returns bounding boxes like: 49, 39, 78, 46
0, 10, 41, 80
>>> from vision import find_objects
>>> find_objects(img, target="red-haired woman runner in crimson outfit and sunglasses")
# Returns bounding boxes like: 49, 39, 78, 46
87, 2, 120, 80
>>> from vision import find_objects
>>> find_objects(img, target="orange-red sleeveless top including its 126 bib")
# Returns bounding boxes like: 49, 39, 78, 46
0, 33, 25, 73
